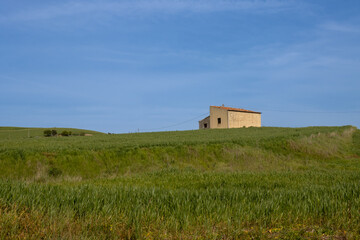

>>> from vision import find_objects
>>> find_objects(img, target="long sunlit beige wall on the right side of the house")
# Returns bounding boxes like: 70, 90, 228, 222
228, 111, 261, 128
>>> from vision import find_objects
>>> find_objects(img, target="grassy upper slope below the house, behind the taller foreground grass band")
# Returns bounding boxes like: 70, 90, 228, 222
0, 127, 353, 180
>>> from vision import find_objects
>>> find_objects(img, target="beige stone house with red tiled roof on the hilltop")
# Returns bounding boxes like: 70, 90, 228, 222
199, 105, 261, 129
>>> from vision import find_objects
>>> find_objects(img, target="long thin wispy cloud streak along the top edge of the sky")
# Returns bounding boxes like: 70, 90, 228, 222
0, 0, 298, 22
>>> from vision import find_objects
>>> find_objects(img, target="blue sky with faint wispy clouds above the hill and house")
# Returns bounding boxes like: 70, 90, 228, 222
0, 0, 360, 133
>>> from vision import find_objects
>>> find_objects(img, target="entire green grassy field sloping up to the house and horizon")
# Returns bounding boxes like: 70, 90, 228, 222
0, 126, 360, 239
